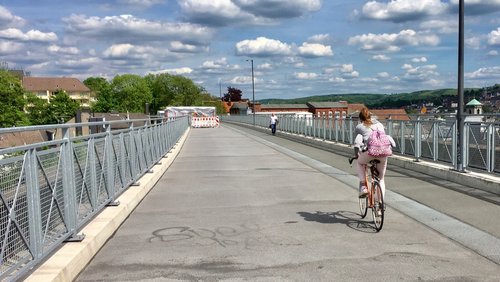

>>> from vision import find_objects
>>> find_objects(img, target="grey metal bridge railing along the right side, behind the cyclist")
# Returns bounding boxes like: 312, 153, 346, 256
221, 115, 500, 173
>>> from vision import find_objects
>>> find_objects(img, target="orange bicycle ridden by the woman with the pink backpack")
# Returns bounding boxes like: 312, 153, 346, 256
349, 158, 385, 232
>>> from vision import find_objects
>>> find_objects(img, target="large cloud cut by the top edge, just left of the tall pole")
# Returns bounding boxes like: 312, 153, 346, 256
362, 0, 447, 22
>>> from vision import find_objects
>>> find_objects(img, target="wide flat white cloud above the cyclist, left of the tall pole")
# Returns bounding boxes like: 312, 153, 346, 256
348, 29, 439, 52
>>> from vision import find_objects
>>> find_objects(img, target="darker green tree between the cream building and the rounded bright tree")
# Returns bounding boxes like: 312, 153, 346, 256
83, 77, 114, 113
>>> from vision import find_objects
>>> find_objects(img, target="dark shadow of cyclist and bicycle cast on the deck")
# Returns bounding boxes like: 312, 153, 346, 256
297, 211, 377, 233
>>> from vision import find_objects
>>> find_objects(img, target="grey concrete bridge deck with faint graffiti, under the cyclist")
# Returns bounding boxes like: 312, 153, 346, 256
27, 124, 500, 281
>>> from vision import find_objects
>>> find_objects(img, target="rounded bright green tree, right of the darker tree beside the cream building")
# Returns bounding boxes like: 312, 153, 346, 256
111, 74, 153, 113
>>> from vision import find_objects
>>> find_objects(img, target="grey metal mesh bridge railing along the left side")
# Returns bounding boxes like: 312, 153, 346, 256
0, 117, 189, 281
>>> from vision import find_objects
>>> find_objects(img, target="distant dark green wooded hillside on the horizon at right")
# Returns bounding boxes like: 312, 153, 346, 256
259, 88, 483, 108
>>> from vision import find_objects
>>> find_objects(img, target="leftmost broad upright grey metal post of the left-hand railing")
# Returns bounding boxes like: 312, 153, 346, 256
25, 149, 43, 260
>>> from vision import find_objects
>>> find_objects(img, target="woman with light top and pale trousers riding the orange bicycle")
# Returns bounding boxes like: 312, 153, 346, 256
354, 107, 395, 198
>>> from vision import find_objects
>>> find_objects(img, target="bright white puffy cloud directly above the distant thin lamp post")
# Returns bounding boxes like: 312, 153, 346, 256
236, 37, 292, 57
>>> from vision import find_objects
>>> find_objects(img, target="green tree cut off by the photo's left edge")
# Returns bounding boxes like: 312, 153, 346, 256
0, 70, 29, 127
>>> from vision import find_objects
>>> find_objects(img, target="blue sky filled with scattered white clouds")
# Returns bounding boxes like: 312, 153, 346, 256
0, 0, 500, 101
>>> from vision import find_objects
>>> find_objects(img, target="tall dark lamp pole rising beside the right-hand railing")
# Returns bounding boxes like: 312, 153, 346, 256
456, 0, 464, 172
